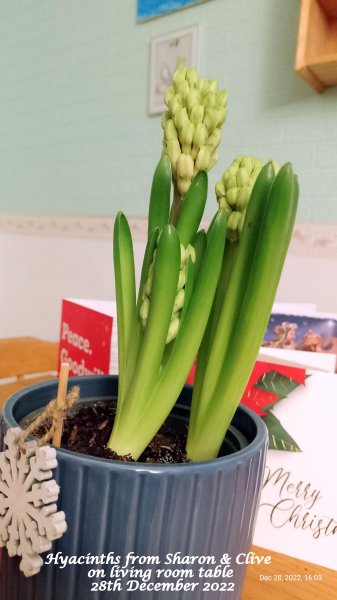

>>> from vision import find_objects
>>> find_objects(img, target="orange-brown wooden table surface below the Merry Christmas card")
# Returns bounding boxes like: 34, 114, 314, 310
241, 546, 337, 600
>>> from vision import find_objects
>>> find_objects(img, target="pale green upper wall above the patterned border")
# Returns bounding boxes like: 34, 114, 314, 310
0, 0, 337, 221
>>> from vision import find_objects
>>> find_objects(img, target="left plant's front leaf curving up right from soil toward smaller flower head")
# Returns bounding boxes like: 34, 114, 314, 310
114, 210, 227, 459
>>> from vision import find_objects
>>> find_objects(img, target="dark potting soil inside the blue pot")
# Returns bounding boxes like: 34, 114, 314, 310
61, 400, 189, 463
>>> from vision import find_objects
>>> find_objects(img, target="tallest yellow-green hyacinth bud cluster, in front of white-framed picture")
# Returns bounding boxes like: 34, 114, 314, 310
162, 64, 227, 196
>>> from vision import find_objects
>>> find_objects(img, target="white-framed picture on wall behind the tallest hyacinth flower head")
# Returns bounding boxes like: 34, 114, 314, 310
149, 25, 200, 115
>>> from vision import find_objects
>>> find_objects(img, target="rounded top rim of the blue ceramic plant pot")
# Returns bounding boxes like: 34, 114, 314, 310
2, 375, 267, 473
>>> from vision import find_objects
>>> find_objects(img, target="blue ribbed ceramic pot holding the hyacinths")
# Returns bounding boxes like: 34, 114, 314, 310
0, 376, 267, 600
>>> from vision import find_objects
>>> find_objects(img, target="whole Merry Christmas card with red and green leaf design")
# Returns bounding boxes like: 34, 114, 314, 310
242, 362, 337, 569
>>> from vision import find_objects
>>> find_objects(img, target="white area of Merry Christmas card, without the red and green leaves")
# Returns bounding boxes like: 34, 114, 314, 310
254, 373, 337, 569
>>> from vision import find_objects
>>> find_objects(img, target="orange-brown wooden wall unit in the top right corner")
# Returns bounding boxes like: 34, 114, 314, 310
295, 0, 337, 93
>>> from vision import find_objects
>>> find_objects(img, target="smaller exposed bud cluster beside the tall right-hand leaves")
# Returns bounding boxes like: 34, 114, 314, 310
215, 156, 263, 241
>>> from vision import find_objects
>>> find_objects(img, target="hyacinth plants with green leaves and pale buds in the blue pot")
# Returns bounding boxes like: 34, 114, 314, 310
108, 64, 298, 461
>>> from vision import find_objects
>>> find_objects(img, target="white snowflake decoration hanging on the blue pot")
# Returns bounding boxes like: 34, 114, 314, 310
0, 427, 67, 577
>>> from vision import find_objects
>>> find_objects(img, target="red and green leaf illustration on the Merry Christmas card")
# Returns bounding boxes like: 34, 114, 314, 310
241, 362, 306, 452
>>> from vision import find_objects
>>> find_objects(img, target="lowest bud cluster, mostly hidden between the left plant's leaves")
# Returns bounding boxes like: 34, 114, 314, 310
139, 244, 196, 344
